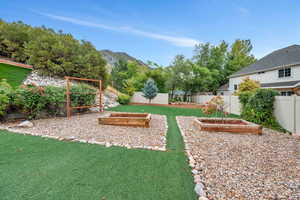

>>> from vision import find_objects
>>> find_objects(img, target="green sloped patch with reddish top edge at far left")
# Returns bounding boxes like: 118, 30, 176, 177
0, 63, 31, 87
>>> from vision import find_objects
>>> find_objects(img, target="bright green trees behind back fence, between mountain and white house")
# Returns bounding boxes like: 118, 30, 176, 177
111, 40, 256, 99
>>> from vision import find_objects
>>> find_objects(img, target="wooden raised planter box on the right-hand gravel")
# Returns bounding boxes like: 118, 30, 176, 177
194, 118, 262, 135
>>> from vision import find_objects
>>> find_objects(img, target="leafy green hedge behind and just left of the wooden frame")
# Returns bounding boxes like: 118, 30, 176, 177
11, 84, 97, 119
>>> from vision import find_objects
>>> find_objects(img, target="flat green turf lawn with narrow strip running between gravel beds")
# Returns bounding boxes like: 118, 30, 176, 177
0, 106, 232, 200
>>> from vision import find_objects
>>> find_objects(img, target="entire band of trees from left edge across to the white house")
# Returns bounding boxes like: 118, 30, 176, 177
0, 20, 256, 96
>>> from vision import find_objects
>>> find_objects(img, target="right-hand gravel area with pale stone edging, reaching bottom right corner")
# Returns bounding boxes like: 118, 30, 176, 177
177, 117, 300, 200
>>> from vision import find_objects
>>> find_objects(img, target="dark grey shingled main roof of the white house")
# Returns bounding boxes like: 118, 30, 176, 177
230, 45, 300, 77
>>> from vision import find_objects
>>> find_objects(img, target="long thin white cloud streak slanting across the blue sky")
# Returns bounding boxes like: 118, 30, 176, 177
39, 13, 200, 47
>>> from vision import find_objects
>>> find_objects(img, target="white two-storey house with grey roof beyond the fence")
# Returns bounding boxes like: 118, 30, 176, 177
227, 45, 300, 96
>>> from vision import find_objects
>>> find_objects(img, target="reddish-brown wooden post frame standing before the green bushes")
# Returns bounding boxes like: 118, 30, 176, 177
65, 76, 103, 118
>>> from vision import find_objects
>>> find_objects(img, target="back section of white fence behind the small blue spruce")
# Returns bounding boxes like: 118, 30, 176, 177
131, 92, 169, 104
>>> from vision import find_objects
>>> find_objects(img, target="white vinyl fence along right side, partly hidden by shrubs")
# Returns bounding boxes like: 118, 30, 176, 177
192, 95, 300, 134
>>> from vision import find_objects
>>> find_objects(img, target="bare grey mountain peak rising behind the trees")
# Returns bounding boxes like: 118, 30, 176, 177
100, 49, 148, 70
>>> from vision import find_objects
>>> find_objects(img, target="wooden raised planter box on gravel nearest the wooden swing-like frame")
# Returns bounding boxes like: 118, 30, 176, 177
98, 113, 151, 128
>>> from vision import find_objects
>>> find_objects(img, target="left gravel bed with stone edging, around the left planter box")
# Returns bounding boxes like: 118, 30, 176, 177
0, 112, 167, 151
